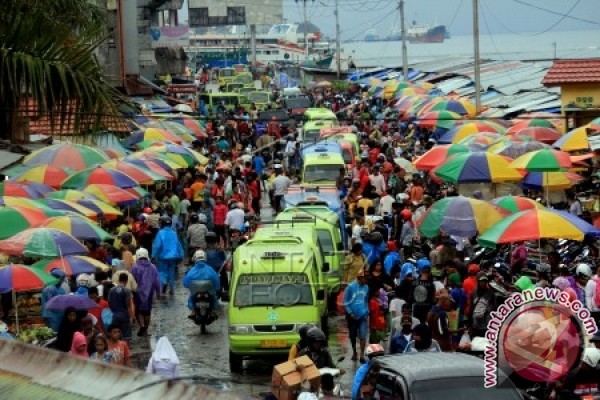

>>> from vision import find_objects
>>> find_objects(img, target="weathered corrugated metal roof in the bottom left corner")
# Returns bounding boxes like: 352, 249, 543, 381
0, 340, 242, 400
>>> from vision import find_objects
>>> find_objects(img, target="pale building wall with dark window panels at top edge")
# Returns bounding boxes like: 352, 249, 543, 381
188, 0, 283, 28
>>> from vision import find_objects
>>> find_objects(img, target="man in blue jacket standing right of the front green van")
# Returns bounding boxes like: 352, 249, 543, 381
344, 269, 369, 363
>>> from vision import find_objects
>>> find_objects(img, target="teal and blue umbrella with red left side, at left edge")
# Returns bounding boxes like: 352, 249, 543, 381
0, 228, 88, 258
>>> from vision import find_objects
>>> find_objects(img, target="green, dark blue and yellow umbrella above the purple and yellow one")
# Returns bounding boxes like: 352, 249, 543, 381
434, 152, 523, 183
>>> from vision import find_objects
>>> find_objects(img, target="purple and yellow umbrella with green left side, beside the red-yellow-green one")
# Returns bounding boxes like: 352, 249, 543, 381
417, 196, 504, 237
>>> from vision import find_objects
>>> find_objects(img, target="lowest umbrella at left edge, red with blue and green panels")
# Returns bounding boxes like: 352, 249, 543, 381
0, 264, 57, 293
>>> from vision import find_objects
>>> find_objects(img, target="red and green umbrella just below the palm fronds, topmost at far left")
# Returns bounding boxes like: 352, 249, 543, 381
23, 143, 108, 171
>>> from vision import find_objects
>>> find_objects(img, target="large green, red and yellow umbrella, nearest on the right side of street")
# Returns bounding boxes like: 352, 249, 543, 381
477, 208, 593, 247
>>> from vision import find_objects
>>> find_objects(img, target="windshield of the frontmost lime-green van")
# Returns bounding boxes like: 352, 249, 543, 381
234, 273, 313, 307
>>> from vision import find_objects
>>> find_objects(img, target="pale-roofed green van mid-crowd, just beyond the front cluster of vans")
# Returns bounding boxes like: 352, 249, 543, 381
302, 153, 346, 185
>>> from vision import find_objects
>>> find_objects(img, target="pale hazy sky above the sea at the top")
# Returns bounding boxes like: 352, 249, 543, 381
180, 0, 600, 40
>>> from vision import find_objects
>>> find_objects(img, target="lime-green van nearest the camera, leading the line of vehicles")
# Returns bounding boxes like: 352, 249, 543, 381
227, 224, 328, 372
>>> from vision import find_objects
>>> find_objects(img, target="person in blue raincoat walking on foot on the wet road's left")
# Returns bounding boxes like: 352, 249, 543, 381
152, 216, 183, 295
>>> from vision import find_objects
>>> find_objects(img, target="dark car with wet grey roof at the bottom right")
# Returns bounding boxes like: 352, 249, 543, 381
359, 353, 523, 400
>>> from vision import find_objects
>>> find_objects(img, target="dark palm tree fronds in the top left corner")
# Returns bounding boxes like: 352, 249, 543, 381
0, 0, 120, 142
